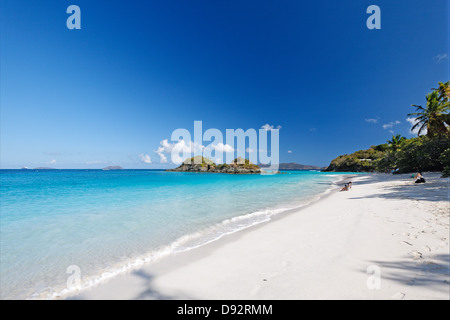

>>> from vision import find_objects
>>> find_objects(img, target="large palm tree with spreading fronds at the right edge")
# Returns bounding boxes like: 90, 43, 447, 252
408, 91, 450, 137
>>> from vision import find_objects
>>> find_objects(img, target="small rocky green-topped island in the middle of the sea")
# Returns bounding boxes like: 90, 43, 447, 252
167, 156, 261, 174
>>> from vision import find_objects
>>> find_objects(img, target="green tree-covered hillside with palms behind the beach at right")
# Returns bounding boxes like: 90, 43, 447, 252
325, 81, 450, 177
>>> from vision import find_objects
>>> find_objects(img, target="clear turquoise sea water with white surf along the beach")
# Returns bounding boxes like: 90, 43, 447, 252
0, 170, 344, 299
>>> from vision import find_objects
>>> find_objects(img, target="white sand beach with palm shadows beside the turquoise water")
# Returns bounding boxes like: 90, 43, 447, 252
71, 173, 450, 299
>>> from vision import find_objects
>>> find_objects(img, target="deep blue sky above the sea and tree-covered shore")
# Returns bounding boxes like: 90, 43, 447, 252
0, 0, 450, 168
